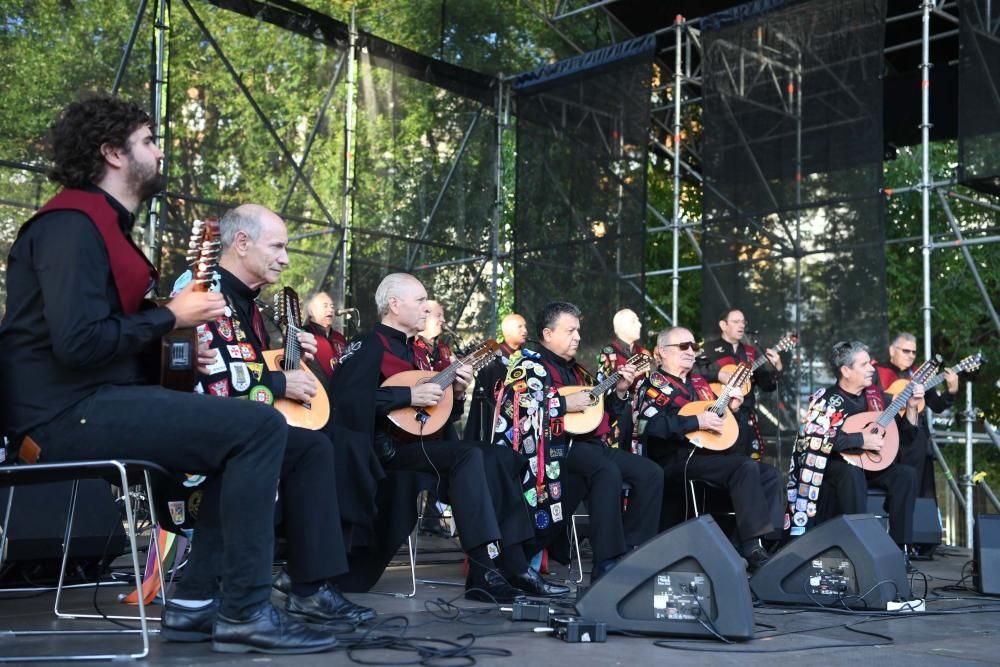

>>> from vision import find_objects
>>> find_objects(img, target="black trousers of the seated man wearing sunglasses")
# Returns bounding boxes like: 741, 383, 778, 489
654, 447, 784, 541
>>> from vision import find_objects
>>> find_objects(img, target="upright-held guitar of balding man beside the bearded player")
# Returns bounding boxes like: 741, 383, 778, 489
264, 287, 330, 431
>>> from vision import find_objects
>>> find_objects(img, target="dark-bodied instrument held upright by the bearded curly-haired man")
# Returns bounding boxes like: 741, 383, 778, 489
160, 220, 222, 392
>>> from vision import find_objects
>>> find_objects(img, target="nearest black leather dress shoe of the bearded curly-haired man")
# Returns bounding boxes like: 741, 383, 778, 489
212, 602, 337, 654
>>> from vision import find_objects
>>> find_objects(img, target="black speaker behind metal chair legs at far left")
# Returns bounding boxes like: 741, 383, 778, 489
0, 479, 125, 563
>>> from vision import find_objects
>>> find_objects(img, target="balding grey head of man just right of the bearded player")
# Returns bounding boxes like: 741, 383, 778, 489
219, 204, 288, 289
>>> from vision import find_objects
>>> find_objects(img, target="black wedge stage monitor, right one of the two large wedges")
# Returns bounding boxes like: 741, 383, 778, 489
750, 514, 912, 609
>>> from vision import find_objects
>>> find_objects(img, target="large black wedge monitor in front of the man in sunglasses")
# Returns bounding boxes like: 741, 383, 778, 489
576, 515, 754, 639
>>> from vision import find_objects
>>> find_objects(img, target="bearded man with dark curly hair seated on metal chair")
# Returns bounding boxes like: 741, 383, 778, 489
0, 97, 337, 653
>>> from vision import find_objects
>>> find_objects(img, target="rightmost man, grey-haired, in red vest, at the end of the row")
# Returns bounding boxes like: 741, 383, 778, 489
873, 332, 958, 498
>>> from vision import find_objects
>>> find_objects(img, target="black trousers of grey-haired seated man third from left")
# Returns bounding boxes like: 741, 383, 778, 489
382, 440, 534, 553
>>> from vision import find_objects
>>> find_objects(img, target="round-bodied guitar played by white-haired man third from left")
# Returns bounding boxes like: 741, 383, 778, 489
382, 338, 500, 437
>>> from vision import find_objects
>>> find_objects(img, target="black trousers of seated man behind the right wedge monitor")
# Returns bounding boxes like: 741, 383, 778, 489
817, 455, 917, 545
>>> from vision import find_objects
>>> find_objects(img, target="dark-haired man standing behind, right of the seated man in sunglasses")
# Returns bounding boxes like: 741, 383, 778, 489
703, 308, 781, 461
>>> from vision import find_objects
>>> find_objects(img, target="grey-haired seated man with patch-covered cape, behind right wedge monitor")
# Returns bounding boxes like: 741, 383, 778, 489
788, 341, 924, 547
